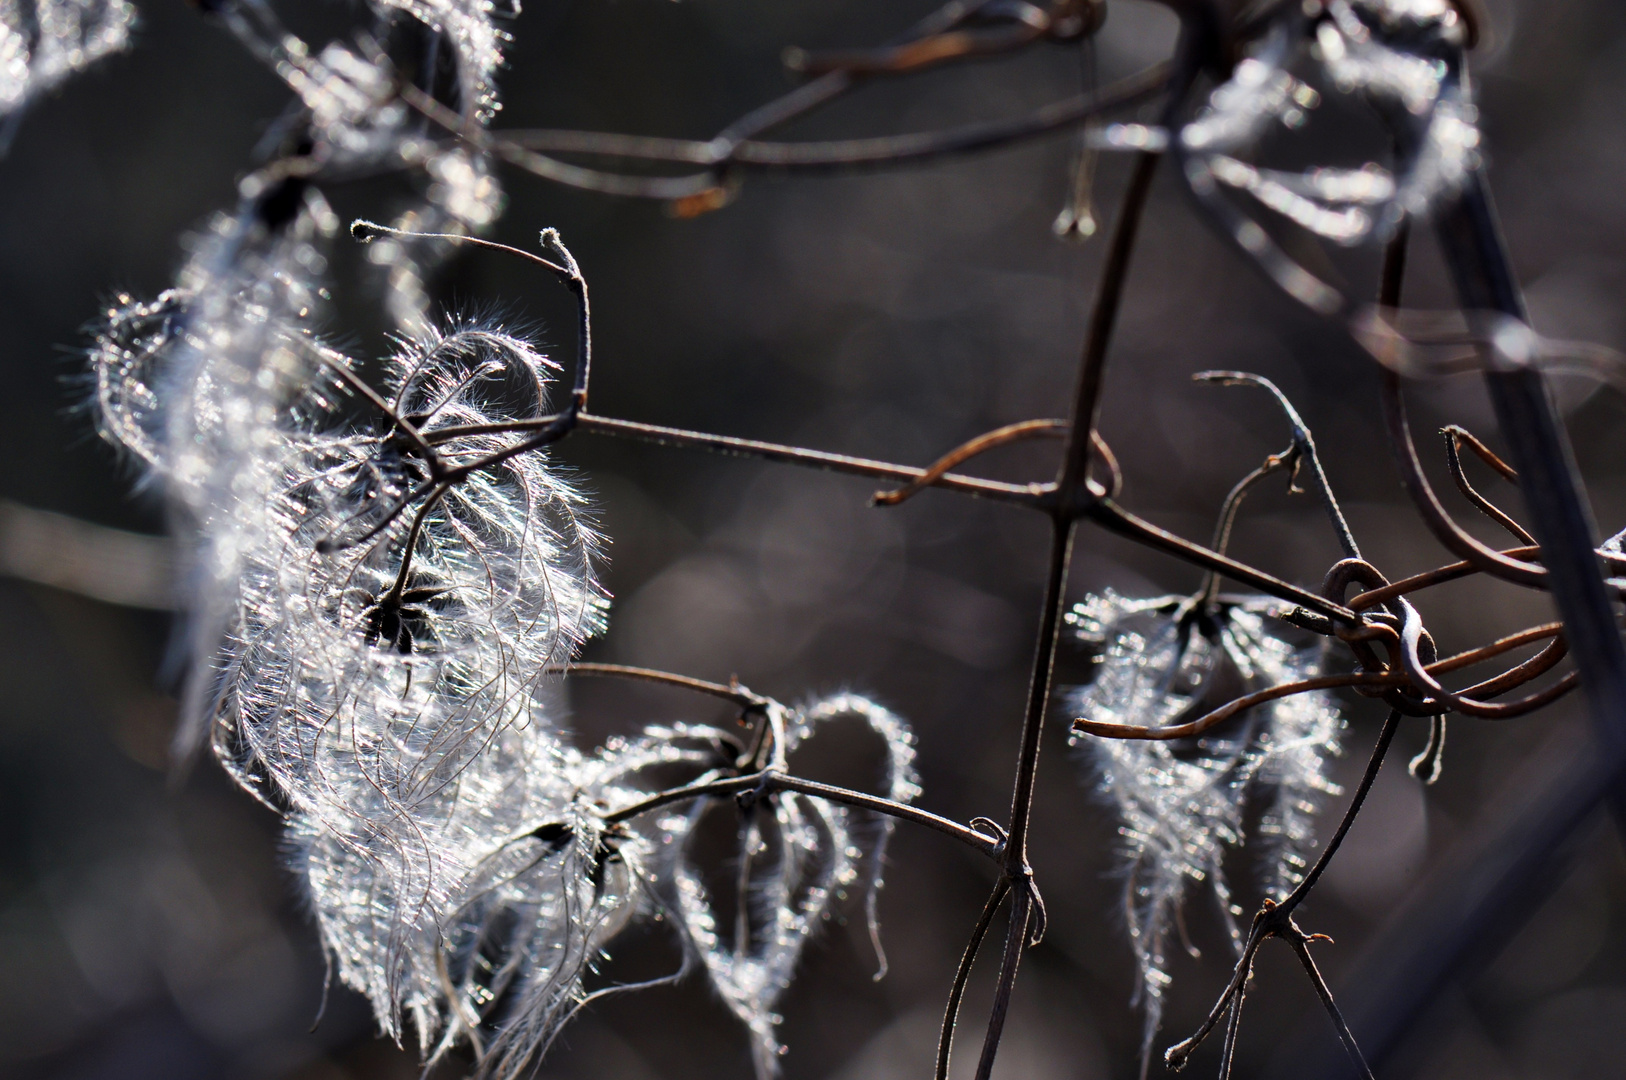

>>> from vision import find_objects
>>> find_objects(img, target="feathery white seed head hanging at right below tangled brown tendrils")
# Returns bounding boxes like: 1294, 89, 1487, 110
1068, 589, 1343, 1072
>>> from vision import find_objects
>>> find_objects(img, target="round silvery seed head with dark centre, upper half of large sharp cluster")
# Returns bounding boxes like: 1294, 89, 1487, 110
216, 325, 605, 803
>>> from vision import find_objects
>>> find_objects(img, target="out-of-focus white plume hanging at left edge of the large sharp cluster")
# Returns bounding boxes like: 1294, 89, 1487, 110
89, 187, 335, 755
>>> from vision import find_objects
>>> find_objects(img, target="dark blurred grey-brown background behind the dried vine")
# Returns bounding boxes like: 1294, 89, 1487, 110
0, 0, 1626, 1080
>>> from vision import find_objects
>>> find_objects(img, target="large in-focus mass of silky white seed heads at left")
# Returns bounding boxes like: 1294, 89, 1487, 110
125, 310, 614, 1077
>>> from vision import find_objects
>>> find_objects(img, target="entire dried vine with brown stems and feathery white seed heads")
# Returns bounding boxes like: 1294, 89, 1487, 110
38, 0, 1626, 1080
